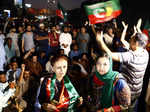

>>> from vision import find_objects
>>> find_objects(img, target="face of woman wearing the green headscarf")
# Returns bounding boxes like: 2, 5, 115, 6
96, 57, 110, 75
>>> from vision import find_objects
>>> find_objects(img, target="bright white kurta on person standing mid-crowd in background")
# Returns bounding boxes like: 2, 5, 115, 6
59, 33, 72, 56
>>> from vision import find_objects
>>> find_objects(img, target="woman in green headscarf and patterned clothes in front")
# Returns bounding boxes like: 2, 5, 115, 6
89, 52, 131, 112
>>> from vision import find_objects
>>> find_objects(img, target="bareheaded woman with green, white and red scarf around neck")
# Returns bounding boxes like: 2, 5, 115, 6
38, 56, 82, 112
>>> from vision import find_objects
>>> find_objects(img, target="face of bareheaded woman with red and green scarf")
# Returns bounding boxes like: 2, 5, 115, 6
53, 59, 68, 77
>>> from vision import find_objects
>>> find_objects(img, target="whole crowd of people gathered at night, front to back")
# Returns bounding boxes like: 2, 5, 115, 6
0, 18, 150, 112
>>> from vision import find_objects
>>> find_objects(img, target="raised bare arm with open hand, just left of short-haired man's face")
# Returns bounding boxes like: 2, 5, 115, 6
121, 21, 129, 49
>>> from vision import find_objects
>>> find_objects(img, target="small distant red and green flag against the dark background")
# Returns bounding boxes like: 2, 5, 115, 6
56, 2, 67, 21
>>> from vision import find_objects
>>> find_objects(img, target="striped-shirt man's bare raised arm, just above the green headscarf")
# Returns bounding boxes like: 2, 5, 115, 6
96, 32, 120, 61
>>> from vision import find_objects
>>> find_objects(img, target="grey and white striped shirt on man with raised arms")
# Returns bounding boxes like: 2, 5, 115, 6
120, 49, 149, 96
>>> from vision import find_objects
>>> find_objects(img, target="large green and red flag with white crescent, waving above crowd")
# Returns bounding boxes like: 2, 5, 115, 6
85, 0, 121, 24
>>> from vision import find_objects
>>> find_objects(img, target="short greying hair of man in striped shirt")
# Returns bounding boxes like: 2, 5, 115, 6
132, 33, 148, 48
